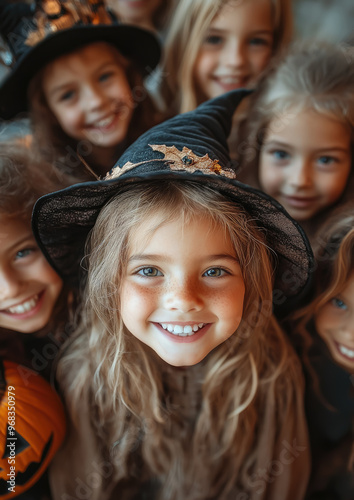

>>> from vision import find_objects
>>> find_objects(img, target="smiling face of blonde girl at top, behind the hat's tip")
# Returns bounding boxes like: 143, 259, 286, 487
194, 0, 274, 100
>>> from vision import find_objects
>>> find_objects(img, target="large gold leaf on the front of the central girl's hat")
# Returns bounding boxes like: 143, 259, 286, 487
150, 144, 236, 179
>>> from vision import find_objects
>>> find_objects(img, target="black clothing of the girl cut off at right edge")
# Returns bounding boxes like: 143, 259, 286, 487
305, 332, 354, 500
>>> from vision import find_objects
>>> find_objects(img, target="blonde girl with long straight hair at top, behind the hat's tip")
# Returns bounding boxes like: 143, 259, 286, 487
161, 0, 292, 114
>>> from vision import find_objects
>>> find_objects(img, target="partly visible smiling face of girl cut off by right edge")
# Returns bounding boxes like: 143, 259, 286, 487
315, 273, 354, 373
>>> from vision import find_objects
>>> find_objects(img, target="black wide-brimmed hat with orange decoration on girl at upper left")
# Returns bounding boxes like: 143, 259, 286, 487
0, 0, 161, 120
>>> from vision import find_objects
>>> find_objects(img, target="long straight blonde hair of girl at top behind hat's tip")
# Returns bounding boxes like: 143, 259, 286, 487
161, 0, 293, 114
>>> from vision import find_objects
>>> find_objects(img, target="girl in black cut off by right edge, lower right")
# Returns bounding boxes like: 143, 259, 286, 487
294, 203, 354, 500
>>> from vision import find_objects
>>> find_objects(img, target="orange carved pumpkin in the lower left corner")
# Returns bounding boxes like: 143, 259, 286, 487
0, 360, 66, 499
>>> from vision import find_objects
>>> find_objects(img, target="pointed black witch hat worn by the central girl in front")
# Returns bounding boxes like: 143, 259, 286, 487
33, 90, 312, 305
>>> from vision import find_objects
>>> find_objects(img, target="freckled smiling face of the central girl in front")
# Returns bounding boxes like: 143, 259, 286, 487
120, 217, 245, 366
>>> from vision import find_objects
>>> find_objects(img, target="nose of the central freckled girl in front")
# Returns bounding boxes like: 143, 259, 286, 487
165, 280, 203, 313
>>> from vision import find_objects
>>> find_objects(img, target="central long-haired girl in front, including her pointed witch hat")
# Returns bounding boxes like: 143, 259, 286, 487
33, 92, 311, 500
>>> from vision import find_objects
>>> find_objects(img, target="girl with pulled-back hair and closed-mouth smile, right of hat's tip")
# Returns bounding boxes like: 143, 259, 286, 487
237, 42, 354, 244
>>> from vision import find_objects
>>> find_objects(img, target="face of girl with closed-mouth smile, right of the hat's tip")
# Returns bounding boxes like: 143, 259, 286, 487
259, 109, 351, 221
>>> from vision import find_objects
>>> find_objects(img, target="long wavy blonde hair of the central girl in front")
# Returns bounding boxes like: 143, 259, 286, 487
58, 180, 297, 500
